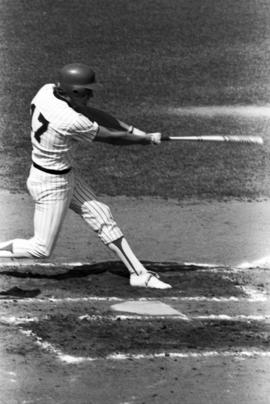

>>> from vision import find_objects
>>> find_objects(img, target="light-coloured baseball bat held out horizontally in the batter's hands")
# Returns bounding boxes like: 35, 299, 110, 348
166, 135, 263, 144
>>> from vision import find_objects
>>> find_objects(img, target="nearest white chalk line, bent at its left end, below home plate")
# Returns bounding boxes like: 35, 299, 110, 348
20, 330, 270, 364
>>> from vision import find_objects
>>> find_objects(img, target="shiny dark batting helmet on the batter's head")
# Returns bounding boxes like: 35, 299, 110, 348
57, 63, 99, 95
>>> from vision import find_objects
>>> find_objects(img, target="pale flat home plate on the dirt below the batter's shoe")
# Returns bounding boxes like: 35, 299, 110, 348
111, 300, 186, 318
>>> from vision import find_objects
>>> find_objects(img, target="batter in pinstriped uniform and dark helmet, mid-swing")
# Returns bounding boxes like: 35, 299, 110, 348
0, 63, 171, 289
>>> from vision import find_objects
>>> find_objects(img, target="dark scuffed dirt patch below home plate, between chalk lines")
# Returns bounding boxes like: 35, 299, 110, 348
20, 313, 270, 357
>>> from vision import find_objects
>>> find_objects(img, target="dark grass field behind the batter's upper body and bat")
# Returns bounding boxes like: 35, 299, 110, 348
0, 0, 270, 200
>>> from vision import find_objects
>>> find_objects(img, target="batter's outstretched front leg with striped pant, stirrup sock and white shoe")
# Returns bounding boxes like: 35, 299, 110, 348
70, 181, 170, 289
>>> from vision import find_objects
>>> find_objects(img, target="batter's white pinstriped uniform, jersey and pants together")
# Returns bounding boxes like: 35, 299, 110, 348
8, 84, 122, 257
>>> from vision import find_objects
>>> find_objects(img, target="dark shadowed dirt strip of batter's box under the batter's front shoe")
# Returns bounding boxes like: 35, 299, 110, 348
0, 261, 236, 299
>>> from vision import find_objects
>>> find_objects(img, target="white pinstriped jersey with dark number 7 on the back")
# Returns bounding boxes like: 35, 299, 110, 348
31, 84, 98, 170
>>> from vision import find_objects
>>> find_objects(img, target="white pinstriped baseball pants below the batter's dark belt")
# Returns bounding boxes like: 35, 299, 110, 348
13, 166, 123, 258
